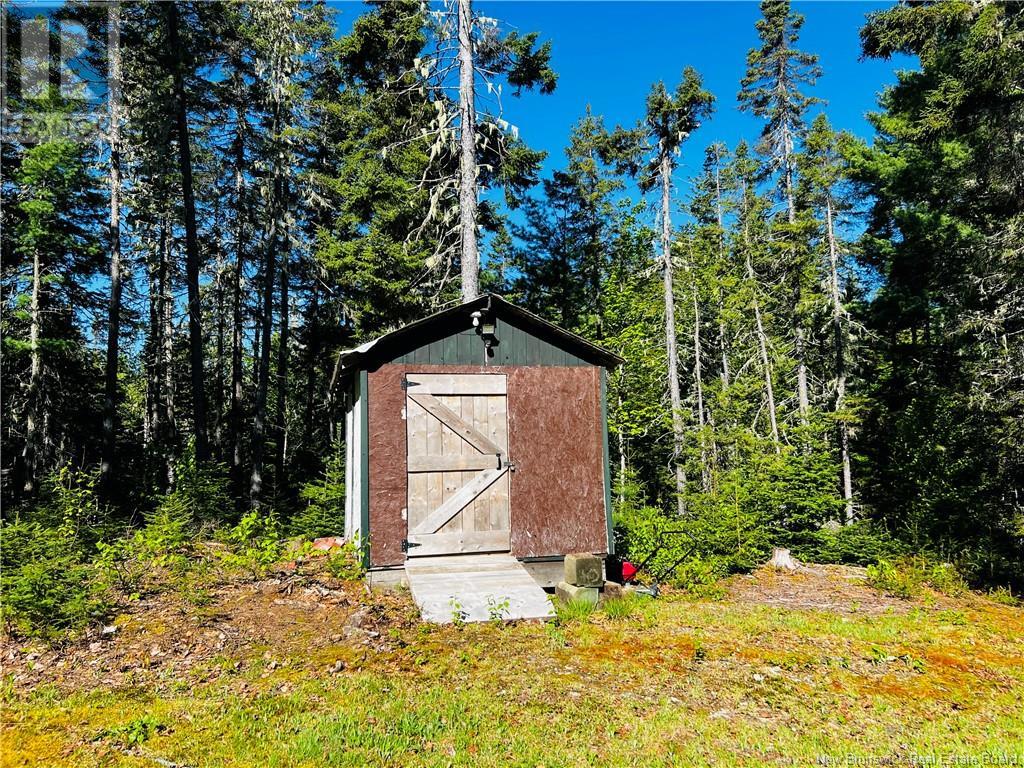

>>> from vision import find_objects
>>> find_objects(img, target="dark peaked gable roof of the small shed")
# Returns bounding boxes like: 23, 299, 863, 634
336, 294, 623, 375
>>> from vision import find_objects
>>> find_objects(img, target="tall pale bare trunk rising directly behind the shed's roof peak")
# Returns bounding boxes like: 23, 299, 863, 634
458, 0, 480, 301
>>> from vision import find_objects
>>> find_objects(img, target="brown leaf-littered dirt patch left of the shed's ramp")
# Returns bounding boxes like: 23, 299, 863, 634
0, 571, 418, 691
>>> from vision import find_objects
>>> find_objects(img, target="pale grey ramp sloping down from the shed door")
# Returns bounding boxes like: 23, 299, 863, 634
406, 553, 554, 624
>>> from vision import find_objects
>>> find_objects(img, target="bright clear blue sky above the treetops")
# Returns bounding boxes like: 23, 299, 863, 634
476, 0, 908, 179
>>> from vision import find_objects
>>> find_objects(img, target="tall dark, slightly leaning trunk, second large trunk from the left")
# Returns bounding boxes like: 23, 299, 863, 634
164, 3, 209, 462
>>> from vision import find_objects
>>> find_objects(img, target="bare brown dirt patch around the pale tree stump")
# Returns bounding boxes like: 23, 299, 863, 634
724, 564, 950, 614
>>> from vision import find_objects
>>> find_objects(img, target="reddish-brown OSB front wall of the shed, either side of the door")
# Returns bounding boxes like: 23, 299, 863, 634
368, 365, 607, 566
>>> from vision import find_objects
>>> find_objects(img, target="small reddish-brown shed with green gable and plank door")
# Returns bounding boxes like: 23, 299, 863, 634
335, 295, 622, 589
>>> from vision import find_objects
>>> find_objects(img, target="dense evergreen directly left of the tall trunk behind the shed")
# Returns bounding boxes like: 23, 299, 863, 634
308, 2, 440, 337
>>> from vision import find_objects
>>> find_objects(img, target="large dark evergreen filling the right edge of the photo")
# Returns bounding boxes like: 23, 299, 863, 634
850, 2, 1024, 580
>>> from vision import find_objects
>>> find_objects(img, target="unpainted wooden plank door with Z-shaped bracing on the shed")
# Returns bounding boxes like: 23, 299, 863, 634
406, 374, 510, 557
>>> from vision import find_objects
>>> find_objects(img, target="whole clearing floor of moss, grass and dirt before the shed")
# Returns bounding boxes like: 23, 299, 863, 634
0, 568, 1024, 768
